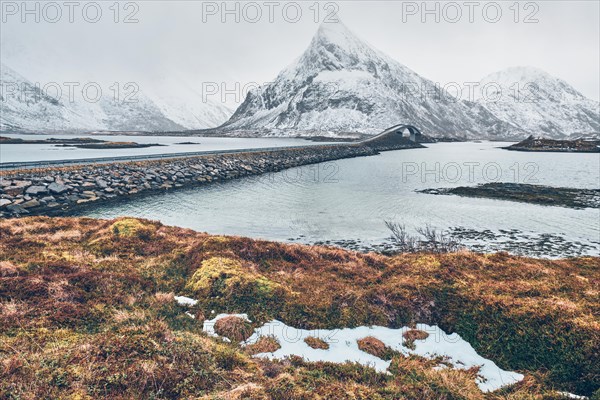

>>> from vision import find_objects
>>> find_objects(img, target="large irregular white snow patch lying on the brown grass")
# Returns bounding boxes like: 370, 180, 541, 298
196, 314, 523, 392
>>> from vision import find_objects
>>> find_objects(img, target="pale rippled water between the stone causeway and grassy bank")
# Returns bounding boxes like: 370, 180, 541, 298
70, 142, 600, 255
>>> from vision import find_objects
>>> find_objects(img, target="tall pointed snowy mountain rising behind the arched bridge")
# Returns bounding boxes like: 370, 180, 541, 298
220, 22, 523, 138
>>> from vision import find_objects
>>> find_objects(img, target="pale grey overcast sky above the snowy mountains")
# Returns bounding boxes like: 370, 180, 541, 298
0, 1, 600, 105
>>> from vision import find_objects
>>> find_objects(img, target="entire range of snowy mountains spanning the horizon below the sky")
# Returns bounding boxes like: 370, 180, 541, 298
0, 22, 600, 140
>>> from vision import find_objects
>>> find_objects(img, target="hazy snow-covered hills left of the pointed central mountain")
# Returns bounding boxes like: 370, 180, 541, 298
0, 64, 231, 132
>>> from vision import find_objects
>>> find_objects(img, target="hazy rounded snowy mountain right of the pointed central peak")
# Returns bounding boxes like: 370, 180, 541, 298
475, 67, 600, 138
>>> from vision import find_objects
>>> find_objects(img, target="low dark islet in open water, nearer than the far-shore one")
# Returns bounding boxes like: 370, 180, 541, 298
417, 182, 600, 209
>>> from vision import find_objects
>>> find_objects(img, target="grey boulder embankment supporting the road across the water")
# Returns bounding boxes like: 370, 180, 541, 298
0, 144, 421, 217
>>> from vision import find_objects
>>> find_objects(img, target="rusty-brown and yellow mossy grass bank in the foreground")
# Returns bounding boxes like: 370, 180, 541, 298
0, 217, 600, 399
